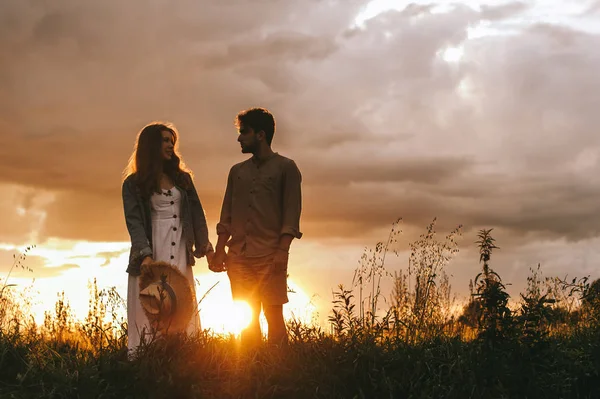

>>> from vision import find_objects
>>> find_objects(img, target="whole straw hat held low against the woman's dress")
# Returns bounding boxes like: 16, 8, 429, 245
138, 262, 196, 332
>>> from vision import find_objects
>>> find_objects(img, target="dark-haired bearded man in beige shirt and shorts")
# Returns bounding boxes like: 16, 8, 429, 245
209, 108, 302, 345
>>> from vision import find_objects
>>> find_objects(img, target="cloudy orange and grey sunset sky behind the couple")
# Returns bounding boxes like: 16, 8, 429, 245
0, 0, 600, 325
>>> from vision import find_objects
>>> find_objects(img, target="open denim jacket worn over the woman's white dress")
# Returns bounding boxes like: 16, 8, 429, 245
122, 174, 212, 276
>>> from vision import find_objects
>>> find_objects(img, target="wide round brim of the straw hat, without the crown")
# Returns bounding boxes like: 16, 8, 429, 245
138, 262, 196, 333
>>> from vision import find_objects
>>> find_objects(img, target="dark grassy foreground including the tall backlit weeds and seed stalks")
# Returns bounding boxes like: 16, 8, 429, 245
0, 223, 600, 398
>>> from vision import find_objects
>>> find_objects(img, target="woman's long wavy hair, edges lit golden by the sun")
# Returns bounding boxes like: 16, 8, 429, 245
123, 122, 192, 198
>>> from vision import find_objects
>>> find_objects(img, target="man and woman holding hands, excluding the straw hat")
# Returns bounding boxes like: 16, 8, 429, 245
122, 108, 302, 351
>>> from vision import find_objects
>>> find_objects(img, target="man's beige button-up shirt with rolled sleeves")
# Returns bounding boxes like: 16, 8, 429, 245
217, 153, 302, 257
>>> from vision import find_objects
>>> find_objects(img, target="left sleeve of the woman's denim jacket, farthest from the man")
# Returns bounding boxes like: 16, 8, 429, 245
121, 180, 152, 258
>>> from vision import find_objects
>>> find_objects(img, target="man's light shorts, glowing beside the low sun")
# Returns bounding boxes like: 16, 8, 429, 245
225, 255, 288, 305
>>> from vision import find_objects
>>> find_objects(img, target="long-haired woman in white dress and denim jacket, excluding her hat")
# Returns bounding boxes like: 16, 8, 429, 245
122, 123, 214, 352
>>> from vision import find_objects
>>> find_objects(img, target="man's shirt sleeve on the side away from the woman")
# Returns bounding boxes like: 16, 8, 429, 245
281, 160, 302, 238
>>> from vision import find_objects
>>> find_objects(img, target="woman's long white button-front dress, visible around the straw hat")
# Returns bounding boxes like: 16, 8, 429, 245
127, 187, 200, 352
